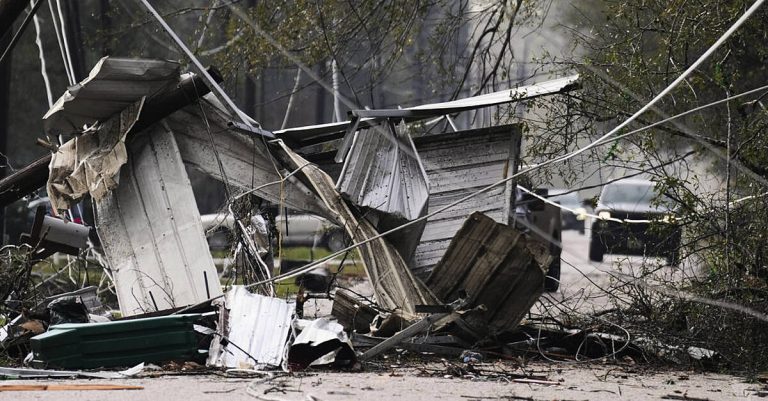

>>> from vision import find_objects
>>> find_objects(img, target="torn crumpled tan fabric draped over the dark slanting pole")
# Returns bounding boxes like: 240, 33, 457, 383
46, 98, 144, 210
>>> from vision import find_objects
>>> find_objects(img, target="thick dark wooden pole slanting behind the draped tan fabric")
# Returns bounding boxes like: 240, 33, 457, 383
0, 67, 223, 207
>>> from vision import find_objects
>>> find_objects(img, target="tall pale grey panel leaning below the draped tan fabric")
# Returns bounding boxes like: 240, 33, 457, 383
94, 125, 222, 316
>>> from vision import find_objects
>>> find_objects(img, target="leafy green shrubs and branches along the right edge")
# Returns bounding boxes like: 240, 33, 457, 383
556, 0, 768, 370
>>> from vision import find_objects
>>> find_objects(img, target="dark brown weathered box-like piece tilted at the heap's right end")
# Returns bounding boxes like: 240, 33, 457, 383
426, 212, 552, 334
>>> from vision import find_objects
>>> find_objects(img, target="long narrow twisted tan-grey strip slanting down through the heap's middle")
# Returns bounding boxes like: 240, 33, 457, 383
278, 141, 437, 318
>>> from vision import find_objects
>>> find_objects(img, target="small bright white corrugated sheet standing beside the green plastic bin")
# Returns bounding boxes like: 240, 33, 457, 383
208, 286, 294, 368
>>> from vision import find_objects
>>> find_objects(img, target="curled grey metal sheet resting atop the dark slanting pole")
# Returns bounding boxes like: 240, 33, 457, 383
43, 57, 179, 136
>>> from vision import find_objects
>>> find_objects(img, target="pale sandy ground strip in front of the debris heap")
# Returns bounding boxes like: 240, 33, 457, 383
0, 360, 768, 401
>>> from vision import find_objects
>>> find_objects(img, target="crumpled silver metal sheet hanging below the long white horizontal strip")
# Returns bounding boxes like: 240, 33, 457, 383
336, 122, 429, 260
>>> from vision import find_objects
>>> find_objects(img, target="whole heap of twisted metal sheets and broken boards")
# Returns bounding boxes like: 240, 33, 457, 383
0, 57, 588, 374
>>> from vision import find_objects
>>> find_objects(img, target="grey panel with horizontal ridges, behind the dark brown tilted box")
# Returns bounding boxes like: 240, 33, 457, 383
411, 125, 520, 278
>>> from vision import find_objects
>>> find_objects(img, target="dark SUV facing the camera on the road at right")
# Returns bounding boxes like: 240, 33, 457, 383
589, 179, 681, 266
